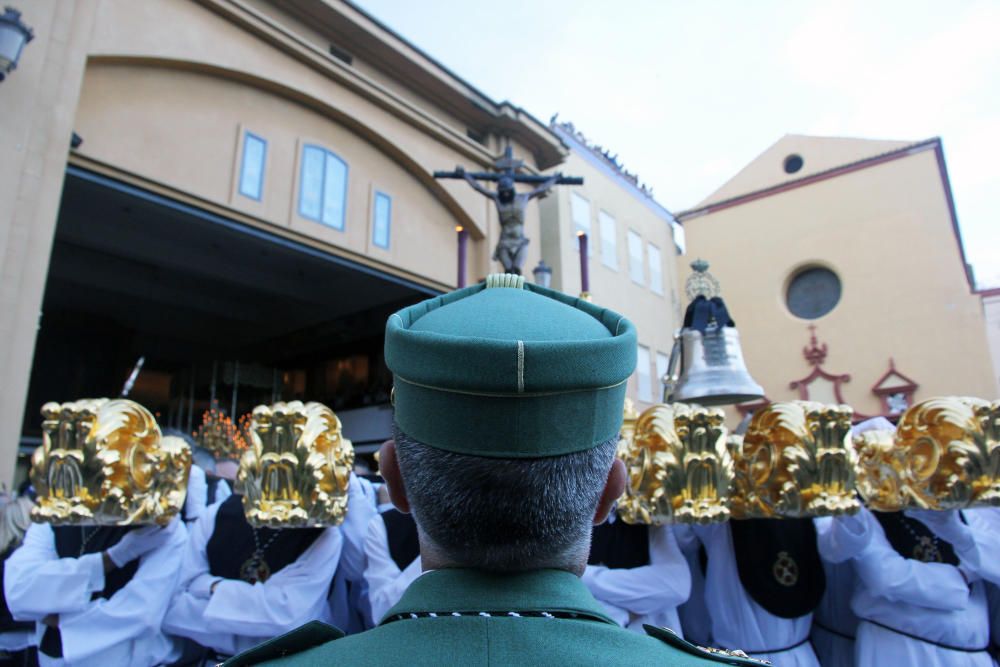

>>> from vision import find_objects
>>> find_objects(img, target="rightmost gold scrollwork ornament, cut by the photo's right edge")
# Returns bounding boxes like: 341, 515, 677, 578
855, 396, 1000, 511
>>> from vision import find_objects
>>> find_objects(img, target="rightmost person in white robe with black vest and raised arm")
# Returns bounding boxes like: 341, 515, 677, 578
818, 418, 1000, 667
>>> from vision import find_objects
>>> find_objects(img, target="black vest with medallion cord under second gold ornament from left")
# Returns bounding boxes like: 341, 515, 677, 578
205, 494, 325, 579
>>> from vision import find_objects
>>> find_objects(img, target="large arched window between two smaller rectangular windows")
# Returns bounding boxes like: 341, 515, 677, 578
299, 145, 347, 231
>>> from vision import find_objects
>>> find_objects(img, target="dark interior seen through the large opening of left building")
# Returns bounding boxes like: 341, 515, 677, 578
22, 167, 434, 460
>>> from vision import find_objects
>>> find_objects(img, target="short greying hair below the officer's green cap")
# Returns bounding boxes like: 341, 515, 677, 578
393, 424, 618, 571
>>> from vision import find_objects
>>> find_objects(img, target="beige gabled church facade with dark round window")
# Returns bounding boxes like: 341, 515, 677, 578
678, 135, 998, 418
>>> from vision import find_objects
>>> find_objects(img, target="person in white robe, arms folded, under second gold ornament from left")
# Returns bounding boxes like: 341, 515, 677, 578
163, 475, 370, 664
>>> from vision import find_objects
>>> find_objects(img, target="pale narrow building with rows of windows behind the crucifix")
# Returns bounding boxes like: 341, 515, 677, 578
540, 122, 683, 410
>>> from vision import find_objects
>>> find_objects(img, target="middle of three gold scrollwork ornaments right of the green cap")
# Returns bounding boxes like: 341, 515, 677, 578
731, 401, 860, 518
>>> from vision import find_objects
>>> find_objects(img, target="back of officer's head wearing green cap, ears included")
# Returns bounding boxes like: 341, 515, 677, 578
380, 274, 636, 572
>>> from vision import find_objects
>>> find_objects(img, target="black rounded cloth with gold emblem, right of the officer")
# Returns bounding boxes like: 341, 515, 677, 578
729, 519, 826, 618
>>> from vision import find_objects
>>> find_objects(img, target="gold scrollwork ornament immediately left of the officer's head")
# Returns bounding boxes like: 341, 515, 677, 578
237, 401, 354, 527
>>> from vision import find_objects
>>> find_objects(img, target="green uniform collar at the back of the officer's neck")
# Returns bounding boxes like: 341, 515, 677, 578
385, 568, 615, 625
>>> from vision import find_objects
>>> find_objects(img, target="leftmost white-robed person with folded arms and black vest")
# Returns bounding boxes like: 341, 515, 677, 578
4, 518, 187, 667
